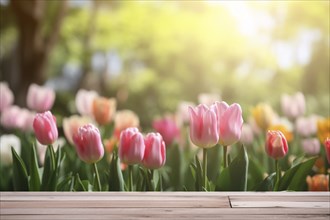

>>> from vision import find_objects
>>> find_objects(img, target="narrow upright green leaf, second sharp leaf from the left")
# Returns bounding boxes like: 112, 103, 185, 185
29, 145, 40, 191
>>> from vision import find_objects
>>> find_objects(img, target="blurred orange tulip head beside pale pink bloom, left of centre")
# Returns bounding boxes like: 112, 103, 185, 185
93, 97, 116, 125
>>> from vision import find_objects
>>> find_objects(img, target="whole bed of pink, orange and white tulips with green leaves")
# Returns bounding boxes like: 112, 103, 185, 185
0, 82, 330, 191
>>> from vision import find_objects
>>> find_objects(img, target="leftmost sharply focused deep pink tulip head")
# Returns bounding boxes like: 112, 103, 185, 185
33, 111, 58, 145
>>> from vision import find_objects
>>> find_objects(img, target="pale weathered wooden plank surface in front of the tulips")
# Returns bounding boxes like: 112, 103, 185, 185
0, 192, 330, 220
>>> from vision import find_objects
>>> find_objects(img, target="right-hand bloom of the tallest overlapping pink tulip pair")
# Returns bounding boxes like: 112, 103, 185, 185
211, 102, 243, 146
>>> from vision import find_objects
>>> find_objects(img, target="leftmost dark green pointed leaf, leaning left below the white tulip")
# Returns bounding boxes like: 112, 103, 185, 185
11, 147, 29, 191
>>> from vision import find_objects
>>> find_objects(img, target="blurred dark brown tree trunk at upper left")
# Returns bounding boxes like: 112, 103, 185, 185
5, 0, 67, 106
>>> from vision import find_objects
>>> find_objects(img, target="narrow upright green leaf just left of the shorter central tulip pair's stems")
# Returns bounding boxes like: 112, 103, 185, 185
109, 152, 125, 191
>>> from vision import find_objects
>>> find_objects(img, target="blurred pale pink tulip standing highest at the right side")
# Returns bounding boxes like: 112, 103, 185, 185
281, 92, 306, 118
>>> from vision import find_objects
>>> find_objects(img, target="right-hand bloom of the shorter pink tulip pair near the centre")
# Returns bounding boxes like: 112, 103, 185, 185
143, 133, 166, 169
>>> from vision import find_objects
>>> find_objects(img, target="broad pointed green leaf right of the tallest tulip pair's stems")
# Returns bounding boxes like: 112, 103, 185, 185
216, 146, 249, 191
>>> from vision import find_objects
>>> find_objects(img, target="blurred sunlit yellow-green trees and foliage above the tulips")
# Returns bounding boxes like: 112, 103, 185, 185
0, 0, 330, 127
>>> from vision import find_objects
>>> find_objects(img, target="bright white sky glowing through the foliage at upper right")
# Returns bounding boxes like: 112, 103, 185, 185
211, 0, 320, 69
